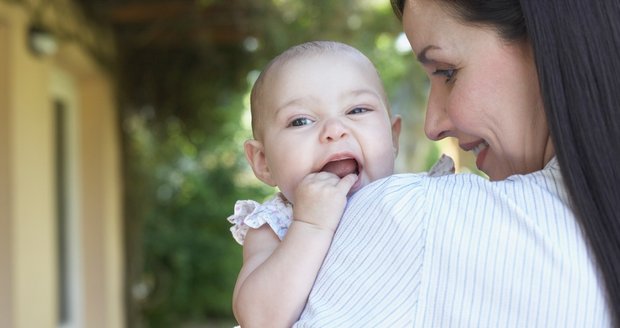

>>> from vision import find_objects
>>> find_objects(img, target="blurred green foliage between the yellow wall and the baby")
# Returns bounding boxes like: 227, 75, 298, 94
123, 84, 271, 327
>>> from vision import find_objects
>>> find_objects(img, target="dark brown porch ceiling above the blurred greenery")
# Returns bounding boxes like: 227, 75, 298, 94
76, 0, 260, 48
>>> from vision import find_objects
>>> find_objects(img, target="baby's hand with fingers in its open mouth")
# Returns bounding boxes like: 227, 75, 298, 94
293, 172, 357, 232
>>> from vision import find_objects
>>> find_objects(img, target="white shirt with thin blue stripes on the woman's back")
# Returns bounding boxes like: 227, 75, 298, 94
295, 160, 611, 327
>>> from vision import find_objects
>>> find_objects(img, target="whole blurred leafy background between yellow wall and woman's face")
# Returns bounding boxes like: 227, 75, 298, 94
76, 0, 438, 327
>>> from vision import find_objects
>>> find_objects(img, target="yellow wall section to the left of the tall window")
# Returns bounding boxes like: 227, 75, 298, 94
2, 5, 56, 327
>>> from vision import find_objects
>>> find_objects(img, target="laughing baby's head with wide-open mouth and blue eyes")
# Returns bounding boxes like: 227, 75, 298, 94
244, 41, 400, 203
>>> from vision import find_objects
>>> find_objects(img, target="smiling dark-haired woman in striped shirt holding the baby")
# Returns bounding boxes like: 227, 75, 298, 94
297, 0, 620, 327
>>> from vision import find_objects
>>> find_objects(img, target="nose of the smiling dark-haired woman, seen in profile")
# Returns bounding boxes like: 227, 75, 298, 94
424, 87, 453, 140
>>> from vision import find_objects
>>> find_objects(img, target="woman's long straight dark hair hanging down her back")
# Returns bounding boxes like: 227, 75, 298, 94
391, 0, 620, 326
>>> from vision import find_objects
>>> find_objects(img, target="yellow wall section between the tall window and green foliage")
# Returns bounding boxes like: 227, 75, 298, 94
74, 52, 123, 328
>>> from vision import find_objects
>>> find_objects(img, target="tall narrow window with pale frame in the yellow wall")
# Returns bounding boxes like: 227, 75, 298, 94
50, 68, 84, 328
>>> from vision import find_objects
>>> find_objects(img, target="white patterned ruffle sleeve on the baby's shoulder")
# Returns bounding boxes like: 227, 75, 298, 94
228, 194, 293, 245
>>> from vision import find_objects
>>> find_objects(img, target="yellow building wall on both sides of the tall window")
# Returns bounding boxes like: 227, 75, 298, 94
0, 2, 124, 328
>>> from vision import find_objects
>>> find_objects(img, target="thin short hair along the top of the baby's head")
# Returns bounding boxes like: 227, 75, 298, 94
250, 41, 379, 140
